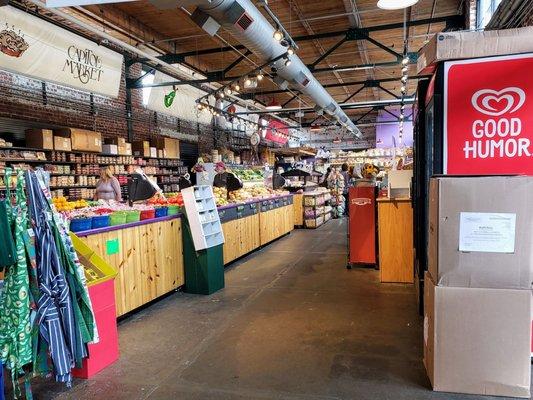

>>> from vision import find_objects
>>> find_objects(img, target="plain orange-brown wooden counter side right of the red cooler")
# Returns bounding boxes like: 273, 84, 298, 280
377, 198, 414, 283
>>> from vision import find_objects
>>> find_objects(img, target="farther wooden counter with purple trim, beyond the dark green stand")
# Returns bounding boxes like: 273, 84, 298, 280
218, 195, 294, 264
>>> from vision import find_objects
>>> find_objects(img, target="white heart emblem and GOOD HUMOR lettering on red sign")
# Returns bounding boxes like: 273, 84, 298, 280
463, 86, 531, 158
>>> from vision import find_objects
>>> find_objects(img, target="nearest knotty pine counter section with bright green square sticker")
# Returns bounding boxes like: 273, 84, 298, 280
77, 216, 185, 316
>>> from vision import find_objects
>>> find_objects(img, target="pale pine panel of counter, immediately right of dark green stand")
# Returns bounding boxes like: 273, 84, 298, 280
222, 214, 261, 264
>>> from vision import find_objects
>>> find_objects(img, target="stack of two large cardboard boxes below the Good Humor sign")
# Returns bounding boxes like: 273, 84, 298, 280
424, 176, 533, 398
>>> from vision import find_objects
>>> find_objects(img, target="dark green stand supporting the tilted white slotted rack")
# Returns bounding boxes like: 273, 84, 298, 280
182, 215, 224, 294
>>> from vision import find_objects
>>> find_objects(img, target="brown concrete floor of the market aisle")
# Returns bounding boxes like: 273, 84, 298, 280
29, 220, 524, 400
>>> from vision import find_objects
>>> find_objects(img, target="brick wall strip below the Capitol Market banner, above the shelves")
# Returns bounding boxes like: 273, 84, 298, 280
0, 65, 218, 152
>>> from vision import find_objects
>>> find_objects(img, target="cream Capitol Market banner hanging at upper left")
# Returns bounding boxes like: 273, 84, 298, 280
0, 6, 123, 97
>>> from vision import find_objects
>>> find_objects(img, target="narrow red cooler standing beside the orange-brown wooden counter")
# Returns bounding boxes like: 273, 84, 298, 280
347, 184, 378, 269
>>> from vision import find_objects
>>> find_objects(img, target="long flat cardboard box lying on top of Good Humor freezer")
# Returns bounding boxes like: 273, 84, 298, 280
417, 26, 533, 74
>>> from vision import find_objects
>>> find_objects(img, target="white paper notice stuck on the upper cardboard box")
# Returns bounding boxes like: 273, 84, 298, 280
459, 212, 516, 253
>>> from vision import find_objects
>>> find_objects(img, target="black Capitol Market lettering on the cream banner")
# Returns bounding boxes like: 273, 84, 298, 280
63, 45, 104, 84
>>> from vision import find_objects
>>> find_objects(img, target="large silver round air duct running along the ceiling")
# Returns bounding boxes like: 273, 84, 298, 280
170, 0, 361, 137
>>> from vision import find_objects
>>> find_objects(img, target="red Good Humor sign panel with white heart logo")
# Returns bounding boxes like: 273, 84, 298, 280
443, 54, 533, 175
